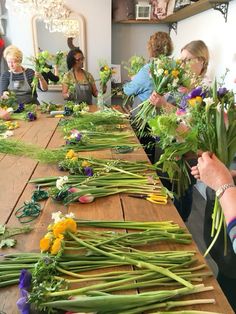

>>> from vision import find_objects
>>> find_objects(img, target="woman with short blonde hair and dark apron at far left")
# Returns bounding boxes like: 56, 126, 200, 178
0, 45, 48, 105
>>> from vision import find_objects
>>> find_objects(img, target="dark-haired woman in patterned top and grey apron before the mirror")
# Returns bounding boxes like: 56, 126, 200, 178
62, 48, 98, 105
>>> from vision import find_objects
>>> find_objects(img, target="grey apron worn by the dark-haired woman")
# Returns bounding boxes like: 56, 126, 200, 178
73, 72, 92, 105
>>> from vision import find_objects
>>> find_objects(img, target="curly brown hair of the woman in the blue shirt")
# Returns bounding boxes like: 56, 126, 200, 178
148, 32, 173, 58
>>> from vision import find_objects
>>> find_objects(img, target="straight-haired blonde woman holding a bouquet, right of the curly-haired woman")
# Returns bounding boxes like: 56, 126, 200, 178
149, 40, 209, 221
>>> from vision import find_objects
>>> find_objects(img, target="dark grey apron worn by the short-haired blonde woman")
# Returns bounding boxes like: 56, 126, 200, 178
8, 71, 39, 104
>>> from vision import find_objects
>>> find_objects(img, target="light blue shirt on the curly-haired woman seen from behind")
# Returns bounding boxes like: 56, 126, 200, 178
123, 63, 154, 102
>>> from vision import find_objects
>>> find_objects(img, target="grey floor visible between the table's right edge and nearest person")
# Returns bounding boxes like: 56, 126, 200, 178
186, 186, 217, 276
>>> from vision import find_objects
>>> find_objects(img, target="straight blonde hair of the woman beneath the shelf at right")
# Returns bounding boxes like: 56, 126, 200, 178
181, 40, 209, 75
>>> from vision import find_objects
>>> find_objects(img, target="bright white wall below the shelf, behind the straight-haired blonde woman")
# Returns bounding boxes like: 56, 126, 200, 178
171, 0, 236, 91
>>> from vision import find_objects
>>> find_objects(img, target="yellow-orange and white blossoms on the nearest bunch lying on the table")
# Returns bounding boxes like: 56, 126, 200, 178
40, 212, 77, 255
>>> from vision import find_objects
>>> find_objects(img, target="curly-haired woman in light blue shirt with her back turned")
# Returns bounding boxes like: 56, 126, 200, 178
123, 32, 173, 163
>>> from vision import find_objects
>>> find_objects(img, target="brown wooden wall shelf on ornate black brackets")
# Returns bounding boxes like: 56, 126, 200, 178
115, 0, 229, 24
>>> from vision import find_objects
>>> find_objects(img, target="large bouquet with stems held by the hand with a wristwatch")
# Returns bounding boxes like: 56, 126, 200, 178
149, 81, 236, 254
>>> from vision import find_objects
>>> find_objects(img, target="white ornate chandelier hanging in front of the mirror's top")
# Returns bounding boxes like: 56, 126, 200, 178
6, 0, 79, 37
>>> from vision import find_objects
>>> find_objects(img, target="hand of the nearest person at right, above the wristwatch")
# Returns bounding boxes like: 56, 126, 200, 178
191, 152, 233, 191
